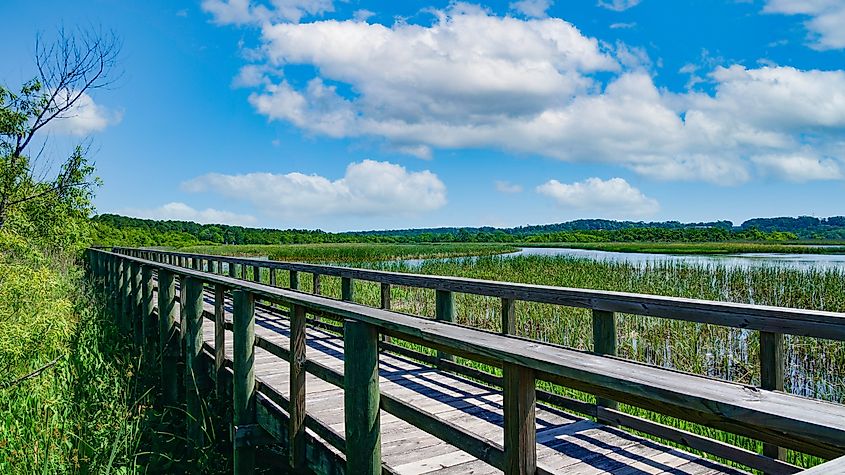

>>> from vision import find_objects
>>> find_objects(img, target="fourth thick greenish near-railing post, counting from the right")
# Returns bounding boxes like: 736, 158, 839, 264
158, 269, 179, 405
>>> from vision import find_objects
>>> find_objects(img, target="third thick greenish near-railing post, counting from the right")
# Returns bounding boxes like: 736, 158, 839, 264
180, 278, 207, 456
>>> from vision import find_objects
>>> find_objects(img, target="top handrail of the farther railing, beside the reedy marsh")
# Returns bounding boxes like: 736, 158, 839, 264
114, 247, 845, 341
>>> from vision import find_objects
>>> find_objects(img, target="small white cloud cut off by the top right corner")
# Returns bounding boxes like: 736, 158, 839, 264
763, 0, 845, 50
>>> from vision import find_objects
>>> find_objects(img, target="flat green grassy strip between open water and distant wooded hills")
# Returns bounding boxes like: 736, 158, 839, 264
520, 242, 845, 254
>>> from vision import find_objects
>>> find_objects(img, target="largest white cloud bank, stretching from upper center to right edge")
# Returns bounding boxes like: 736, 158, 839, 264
214, 2, 845, 185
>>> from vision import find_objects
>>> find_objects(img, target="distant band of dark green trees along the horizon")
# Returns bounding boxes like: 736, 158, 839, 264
87, 214, 845, 247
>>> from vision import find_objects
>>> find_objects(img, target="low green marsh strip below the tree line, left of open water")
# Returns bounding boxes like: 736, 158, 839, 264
180, 243, 518, 263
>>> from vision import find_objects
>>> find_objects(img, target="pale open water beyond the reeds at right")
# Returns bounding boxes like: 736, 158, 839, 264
396, 247, 845, 271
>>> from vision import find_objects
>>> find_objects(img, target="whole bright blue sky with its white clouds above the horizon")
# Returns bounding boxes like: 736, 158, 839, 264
0, 0, 845, 231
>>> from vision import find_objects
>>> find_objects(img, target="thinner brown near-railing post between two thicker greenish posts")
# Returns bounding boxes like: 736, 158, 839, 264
288, 305, 307, 473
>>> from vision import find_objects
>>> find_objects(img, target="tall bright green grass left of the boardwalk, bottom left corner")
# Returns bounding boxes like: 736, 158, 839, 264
0, 233, 147, 474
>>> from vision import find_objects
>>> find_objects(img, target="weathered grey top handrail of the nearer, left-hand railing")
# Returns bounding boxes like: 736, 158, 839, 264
99, 251, 845, 455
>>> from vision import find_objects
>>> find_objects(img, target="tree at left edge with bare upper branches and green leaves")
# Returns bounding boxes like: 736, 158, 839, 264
0, 30, 120, 249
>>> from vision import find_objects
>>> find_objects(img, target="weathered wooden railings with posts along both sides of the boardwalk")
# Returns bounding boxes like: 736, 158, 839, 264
89, 248, 845, 474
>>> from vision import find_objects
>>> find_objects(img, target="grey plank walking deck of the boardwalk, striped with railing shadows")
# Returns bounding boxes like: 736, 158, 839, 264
193, 293, 746, 475
